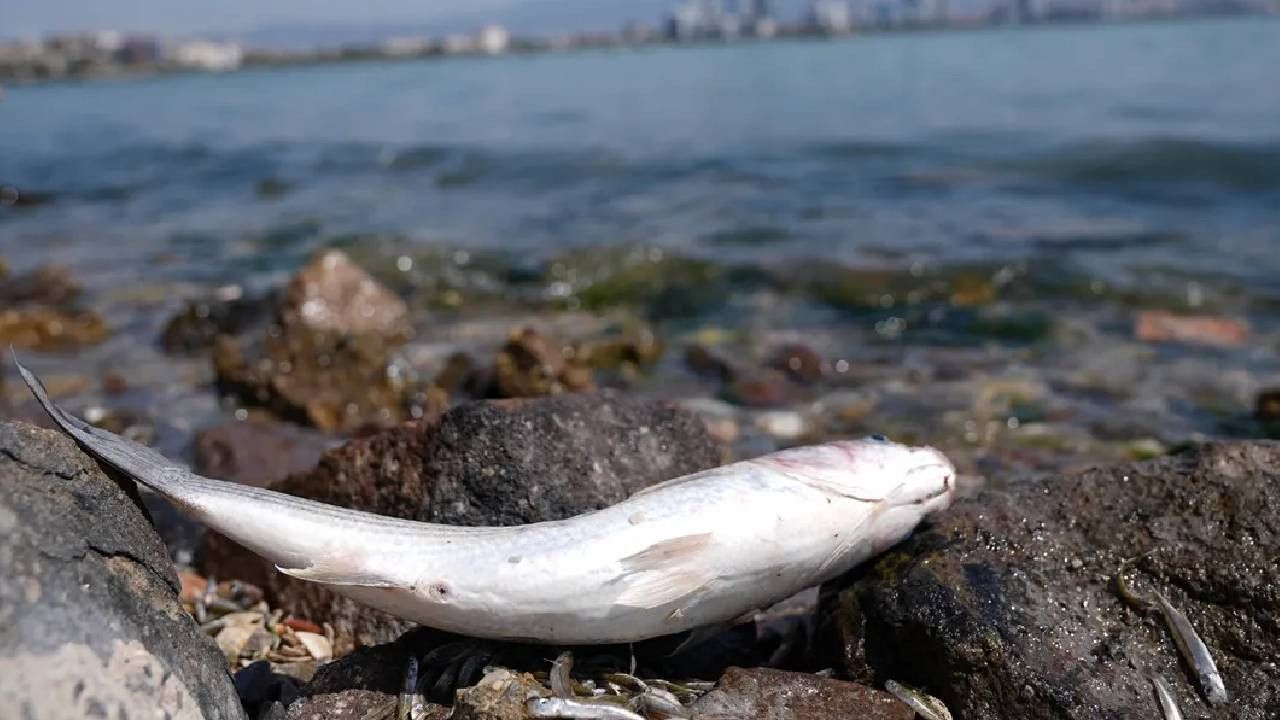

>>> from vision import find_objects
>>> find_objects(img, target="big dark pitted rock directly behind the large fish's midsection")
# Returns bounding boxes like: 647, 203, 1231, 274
205, 392, 722, 655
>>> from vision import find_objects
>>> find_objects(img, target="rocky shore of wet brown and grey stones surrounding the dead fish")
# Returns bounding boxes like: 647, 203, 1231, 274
0, 244, 1280, 720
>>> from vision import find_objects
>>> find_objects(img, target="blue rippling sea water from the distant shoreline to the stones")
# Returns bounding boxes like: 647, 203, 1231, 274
0, 18, 1280, 474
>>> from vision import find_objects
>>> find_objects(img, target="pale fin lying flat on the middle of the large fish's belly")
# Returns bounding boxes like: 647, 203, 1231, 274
616, 533, 716, 607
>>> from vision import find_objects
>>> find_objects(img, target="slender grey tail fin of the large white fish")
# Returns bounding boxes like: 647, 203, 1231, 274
10, 348, 198, 495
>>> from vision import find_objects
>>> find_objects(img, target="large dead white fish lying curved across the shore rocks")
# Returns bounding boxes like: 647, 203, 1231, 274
15, 361, 955, 644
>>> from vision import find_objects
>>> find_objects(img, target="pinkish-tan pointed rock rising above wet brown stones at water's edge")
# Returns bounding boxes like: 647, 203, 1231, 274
280, 250, 412, 345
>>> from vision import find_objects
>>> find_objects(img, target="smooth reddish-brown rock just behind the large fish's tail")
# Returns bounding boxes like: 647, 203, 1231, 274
195, 419, 329, 487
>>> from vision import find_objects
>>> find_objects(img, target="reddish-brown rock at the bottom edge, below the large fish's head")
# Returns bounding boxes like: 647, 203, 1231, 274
692, 667, 915, 720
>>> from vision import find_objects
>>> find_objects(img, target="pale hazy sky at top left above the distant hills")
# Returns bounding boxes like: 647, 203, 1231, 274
0, 0, 529, 36
